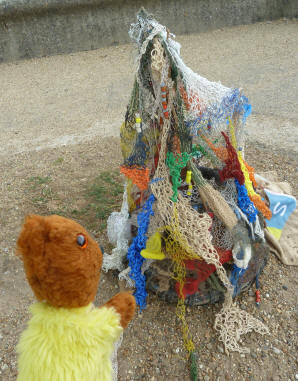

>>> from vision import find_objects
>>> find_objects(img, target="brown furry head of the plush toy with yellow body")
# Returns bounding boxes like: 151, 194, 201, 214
17, 215, 102, 308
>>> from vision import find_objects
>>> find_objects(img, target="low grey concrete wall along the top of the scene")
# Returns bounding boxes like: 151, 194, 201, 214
0, 0, 298, 62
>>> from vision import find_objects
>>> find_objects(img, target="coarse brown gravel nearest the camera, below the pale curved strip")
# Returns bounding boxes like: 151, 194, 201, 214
0, 138, 298, 381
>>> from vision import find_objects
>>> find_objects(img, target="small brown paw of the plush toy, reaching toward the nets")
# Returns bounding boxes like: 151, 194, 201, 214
105, 292, 136, 328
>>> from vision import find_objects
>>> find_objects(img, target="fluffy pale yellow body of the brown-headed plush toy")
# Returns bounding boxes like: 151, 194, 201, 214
17, 303, 122, 381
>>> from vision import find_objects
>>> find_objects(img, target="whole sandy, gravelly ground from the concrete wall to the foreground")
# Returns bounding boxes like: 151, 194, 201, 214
0, 20, 298, 381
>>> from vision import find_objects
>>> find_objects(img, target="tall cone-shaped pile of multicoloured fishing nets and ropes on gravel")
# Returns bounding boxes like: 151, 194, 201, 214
104, 10, 271, 374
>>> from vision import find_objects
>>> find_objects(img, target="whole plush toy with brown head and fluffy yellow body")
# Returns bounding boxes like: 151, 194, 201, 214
17, 215, 136, 381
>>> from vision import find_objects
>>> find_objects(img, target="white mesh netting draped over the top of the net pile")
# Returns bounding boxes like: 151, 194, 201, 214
129, 8, 246, 147
